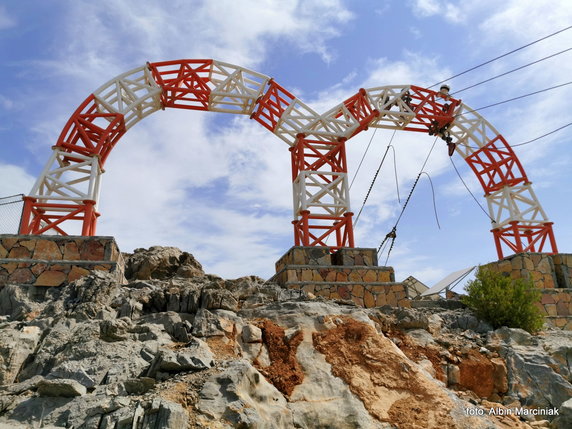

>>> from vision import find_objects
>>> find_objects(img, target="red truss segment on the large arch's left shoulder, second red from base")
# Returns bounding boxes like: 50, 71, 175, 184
56, 94, 126, 166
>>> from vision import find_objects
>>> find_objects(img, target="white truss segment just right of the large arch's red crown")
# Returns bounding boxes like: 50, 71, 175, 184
209, 60, 270, 115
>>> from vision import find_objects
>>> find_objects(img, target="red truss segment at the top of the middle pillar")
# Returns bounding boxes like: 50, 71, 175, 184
290, 134, 348, 180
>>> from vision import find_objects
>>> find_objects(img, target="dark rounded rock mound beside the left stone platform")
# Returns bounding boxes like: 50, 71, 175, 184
125, 246, 204, 280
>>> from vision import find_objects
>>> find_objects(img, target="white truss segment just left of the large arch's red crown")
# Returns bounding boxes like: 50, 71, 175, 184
93, 65, 162, 129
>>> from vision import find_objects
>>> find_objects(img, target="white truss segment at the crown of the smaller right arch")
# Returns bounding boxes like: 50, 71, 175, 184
366, 85, 415, 130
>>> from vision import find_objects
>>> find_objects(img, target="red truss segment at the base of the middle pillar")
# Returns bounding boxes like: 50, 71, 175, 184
292, 210, 355, 251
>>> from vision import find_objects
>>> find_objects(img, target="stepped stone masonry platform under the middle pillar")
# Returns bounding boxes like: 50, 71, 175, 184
273, 246, 410, 308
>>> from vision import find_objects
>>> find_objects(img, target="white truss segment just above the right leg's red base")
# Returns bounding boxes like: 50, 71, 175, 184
485, 183, 548, 228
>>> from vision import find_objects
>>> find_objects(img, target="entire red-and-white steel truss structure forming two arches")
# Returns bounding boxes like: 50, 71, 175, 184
20, 60, 557, 258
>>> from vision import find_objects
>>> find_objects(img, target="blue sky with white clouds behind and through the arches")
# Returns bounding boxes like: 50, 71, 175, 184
0, 0, 572, 284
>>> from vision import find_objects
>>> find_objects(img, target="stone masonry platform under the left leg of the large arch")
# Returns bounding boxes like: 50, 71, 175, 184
0, 234, 124, 288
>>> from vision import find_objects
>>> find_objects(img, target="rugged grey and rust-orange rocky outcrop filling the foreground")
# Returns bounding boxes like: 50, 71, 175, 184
0, 247, 572, 429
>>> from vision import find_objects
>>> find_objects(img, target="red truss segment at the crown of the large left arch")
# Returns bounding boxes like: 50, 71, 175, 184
149, 60, 213, 110
